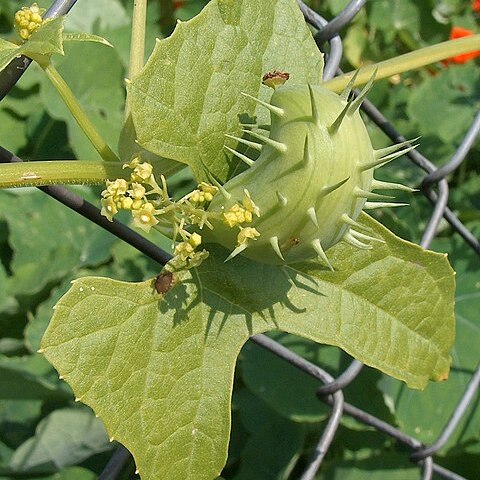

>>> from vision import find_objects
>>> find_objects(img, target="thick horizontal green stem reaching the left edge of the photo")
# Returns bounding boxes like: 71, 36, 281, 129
0, 160, 127, 188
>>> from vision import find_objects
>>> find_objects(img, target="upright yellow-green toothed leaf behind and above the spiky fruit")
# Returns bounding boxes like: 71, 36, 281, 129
128, 0, 323, 181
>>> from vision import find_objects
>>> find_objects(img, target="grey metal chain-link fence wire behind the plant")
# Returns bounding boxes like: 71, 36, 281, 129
0, 0, 480, 480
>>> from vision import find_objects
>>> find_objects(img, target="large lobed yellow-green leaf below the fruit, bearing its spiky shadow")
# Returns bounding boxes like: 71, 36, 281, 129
42, 215, 454, 480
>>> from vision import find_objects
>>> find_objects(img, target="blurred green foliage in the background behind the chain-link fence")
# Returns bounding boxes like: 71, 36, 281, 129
0, 0, 480, 480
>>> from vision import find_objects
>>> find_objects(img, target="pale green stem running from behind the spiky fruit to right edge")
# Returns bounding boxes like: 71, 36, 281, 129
322, 34, 480, 92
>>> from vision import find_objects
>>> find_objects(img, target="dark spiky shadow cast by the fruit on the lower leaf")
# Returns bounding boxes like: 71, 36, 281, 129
159, 245, 323, 337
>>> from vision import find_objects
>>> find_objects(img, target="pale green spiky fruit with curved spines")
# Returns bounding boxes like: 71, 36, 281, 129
205, 79, 408, 266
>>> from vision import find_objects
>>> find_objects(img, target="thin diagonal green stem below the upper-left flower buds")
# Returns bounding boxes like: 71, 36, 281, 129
42, 63, 120, 162
